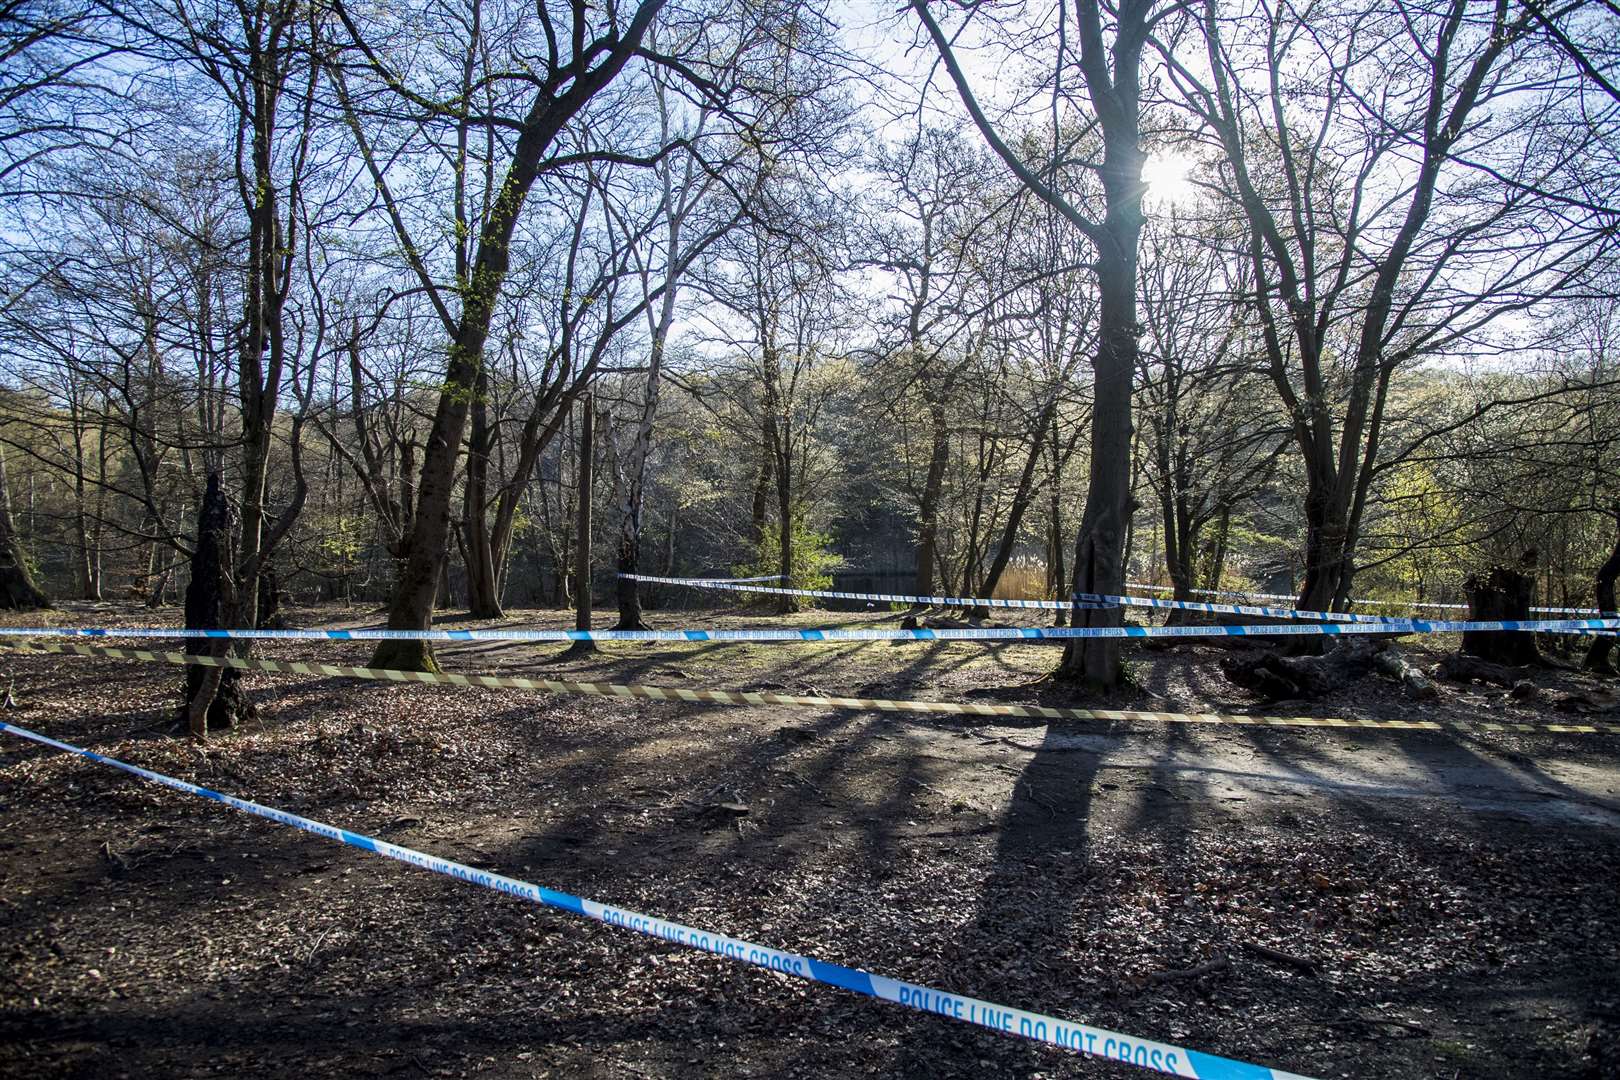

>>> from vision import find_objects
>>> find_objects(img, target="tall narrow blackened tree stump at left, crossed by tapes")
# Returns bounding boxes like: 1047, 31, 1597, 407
180, 473, 253, 738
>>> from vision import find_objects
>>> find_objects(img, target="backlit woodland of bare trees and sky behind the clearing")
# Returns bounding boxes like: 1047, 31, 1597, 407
0, 0, 1620, 687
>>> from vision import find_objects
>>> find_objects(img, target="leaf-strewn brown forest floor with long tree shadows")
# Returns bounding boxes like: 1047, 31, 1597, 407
0, 604, 1620, 1080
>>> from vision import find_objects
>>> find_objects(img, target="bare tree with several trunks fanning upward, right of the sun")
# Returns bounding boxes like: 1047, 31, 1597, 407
1160, 0, 1607, 610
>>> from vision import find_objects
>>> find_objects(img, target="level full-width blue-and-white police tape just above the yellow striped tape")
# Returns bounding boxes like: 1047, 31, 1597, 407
0, 619, 1620, 641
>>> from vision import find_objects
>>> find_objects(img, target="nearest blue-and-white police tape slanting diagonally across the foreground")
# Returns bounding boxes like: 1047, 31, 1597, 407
0, 722, 1307, 1080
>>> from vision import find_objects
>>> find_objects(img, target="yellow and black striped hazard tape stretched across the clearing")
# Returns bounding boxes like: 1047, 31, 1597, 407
0, 644, 1620, 735
